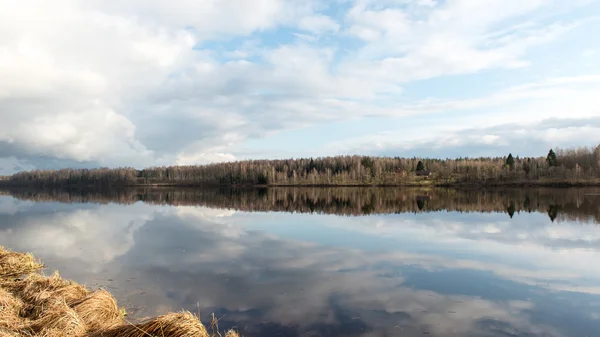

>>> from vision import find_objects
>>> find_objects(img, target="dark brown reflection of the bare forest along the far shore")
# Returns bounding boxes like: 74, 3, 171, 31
2, 187, 600, 223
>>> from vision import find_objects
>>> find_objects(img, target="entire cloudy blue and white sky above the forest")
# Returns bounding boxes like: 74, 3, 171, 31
0, 0, 600, 175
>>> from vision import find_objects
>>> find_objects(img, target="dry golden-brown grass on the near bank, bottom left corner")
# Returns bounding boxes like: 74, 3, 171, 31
0, 247, 238, 337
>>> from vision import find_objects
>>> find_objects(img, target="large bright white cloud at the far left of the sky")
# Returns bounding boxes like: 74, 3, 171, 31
0, 1, 193, 165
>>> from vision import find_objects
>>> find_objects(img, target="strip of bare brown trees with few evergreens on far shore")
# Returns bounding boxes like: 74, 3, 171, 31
0, 145, 600, 187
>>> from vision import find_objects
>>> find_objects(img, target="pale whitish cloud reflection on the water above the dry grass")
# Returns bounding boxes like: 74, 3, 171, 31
0, 202, 161, 272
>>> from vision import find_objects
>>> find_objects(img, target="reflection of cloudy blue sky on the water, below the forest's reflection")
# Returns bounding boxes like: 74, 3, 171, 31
0, 198, 600, 336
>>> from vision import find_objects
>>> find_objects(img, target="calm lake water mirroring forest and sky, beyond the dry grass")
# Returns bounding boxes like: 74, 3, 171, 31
0, 188, 600, 337
